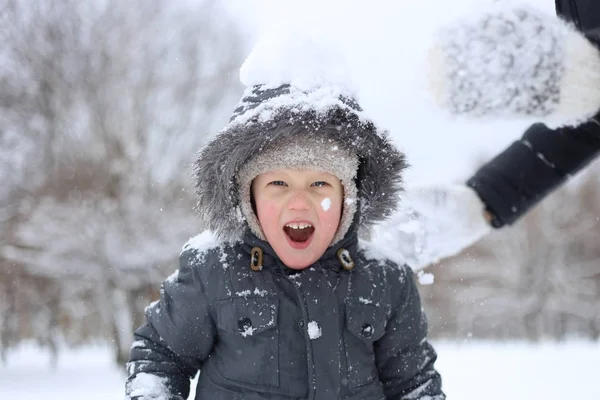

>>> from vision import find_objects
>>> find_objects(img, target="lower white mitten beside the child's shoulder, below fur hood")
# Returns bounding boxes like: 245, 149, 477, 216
371, 184, 492, 270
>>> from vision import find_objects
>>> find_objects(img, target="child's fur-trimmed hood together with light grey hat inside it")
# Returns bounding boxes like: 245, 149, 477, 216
195, 85, 406, 244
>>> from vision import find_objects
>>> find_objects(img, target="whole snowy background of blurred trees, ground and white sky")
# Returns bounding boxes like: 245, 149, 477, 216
0, 0, 600, 400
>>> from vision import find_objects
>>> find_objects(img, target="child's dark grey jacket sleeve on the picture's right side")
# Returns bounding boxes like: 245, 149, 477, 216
375, 266, 446, 400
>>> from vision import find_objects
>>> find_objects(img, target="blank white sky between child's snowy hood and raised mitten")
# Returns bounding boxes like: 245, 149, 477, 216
231, 0, 554, 184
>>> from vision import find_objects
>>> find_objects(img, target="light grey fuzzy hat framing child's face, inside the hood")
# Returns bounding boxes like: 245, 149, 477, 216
237, 131, 358, 245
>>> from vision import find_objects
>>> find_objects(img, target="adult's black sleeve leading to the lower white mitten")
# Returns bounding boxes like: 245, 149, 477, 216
467, 116, 600, 228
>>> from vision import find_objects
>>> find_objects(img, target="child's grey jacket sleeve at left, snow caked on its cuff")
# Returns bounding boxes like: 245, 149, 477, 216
125, 251, 215, 400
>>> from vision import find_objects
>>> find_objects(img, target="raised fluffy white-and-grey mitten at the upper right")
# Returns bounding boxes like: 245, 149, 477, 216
428, 5, 600, 126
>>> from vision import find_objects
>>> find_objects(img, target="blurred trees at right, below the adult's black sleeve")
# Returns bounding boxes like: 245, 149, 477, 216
423, 165, 600, 340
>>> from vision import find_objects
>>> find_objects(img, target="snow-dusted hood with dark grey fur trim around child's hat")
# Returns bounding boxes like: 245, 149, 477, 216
195, 85, 407, 241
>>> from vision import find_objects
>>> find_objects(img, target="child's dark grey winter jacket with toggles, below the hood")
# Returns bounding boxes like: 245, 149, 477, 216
127, 228, 445, 400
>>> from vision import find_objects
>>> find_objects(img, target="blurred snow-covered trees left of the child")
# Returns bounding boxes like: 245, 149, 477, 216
0, 0, 243, 363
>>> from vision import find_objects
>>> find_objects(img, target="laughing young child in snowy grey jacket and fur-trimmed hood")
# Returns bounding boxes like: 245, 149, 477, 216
126, 85, 445, 400
